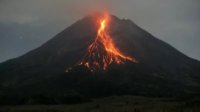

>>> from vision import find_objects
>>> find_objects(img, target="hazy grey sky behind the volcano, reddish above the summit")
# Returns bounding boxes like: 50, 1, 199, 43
0, 0, 200, 62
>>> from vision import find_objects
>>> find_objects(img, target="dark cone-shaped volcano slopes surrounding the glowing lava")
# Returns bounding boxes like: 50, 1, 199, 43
0, 15, 200, 100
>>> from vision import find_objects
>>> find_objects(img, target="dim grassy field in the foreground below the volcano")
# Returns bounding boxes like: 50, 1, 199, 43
0, 96, 200, 112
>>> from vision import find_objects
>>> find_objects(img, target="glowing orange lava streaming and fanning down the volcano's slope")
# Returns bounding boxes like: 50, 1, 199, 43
79, 15, 136, 72
